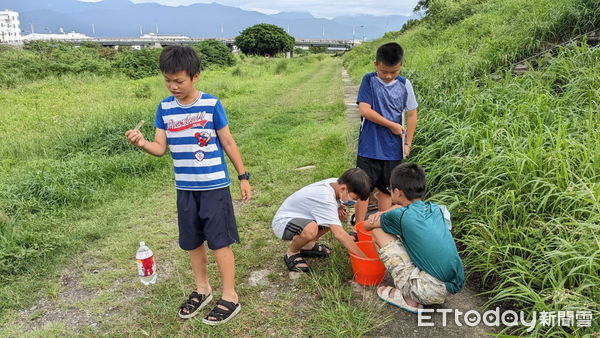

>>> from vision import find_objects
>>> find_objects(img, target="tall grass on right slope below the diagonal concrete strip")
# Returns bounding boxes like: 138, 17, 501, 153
415, 48, 600, 333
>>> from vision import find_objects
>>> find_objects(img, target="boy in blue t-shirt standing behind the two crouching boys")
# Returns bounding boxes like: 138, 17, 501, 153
356, 42, 417, 222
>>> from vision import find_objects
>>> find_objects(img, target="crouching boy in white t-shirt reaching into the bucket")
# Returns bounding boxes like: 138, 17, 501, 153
272, 168, 371, 272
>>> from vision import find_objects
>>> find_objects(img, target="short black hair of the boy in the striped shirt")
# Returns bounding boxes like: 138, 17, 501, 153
159, 46, 200, 78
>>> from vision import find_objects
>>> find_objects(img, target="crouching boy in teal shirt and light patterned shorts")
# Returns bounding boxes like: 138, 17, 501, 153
365, 163, 464, 313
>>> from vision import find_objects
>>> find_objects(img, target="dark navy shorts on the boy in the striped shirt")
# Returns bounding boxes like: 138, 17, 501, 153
177, 187, 240, 250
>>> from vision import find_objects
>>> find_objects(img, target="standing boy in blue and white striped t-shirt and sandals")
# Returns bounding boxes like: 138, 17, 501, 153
125, 46, 251, 325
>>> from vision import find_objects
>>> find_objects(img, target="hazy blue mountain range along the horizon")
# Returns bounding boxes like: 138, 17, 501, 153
0, 0, 413, 40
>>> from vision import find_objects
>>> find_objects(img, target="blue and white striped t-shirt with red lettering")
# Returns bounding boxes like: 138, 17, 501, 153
154, 93, 231, 190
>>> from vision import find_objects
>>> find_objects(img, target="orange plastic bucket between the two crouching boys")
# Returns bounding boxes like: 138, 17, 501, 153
349, 241, 385, 286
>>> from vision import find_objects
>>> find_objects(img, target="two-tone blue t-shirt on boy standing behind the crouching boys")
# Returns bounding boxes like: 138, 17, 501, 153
356, 72, 417, 161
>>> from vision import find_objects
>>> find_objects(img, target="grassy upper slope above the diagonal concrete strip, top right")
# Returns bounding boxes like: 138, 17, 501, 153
344, 0, 600, 91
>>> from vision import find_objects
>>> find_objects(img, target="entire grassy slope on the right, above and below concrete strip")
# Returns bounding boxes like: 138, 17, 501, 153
344, 0, 600, 336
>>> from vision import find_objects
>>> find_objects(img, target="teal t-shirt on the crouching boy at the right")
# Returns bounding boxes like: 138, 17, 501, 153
380, 200, 465, 293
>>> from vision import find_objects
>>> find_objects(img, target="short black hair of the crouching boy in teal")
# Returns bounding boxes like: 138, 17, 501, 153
390, 163, 426, 201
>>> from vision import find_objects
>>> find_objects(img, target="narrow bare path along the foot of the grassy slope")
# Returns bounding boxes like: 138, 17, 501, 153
342, 69, 495, 337
